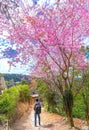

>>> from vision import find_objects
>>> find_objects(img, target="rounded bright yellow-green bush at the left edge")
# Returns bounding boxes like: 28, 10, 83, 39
0, 87, 19, 116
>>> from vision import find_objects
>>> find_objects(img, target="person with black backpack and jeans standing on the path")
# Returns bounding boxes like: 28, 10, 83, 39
34, 99, 41, 126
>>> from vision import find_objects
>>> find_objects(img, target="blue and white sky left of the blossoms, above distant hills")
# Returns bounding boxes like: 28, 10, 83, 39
0, 36, 34, 74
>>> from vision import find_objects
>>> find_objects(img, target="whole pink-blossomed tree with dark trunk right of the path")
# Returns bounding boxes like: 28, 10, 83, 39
2, 0, 89, 126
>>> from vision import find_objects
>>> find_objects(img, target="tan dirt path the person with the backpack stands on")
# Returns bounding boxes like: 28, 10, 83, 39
13, 106, 87, 130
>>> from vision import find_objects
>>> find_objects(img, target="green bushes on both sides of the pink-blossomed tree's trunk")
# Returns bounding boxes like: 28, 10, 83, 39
36, 74, 89, 124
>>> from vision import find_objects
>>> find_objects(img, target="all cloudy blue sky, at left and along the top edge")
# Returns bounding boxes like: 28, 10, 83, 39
0, 0, 54, 74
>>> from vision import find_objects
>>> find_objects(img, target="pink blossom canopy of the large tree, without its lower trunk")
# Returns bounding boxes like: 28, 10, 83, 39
1, 0, 89, 76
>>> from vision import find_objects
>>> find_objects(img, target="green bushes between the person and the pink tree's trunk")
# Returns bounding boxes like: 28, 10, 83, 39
36, 79, 62, 114
